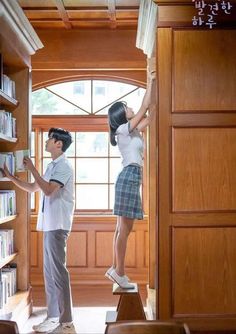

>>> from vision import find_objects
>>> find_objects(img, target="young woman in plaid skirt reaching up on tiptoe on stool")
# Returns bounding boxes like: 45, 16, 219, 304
105, 73, 155, 289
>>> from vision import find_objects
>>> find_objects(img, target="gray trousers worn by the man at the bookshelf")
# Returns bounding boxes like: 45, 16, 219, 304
43, 230, 72, 323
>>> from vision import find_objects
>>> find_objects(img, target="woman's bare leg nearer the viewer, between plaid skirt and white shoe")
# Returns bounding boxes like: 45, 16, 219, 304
115, 217, 134, 276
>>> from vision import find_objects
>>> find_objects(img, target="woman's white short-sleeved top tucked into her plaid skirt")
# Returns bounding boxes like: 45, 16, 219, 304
116, 122, 144, 167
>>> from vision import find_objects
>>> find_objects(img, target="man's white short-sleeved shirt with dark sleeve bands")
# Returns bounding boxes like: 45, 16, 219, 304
37, 154, 74, 232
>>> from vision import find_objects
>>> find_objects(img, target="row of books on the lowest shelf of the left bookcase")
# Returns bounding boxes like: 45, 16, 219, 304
0, 264, 17, 309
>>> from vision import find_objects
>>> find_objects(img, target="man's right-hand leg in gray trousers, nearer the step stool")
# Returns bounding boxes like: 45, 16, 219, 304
48, 230, 73, 323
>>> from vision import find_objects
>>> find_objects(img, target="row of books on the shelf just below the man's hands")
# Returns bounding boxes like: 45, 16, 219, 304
0, 190, 16, 219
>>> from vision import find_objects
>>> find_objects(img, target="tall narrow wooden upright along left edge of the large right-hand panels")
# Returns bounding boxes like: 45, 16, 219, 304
156, 28, 172, 320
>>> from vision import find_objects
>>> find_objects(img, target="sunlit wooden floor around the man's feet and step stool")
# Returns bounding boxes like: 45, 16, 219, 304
20, 284, 147, 334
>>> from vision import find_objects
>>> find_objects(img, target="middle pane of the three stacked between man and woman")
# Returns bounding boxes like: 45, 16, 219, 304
76, 158, 108, 183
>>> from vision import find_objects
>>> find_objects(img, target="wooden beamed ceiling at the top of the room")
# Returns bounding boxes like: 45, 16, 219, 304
18, 0, 140, 29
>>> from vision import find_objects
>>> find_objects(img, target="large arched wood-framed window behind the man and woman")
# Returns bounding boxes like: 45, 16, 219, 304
31, 80, 145, 213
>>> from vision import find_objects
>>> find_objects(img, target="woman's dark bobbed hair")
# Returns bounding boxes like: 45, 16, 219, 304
108, 101, 127, 146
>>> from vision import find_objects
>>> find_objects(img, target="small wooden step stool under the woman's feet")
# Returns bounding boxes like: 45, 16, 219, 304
106, 283, 146, 324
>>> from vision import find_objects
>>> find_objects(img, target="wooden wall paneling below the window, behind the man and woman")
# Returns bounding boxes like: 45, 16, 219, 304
31, 216, 148, 286
